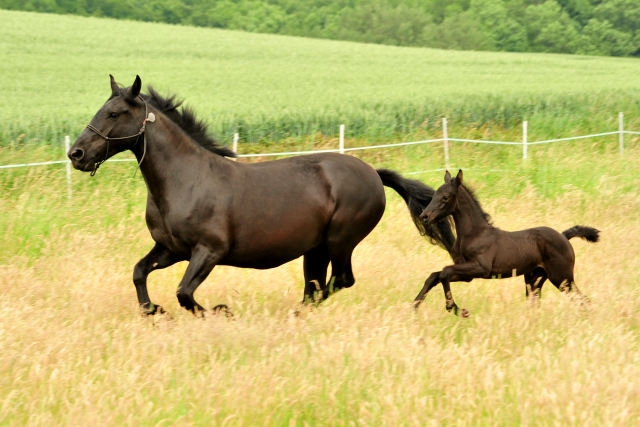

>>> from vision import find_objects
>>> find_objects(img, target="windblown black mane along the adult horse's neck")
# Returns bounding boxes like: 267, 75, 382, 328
112, 85, 236, 157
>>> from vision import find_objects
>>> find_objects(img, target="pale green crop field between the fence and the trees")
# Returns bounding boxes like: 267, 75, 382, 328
0, 11, 640, 146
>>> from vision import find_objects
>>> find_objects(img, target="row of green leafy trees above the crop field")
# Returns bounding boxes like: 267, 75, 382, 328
5, 0, 640, 56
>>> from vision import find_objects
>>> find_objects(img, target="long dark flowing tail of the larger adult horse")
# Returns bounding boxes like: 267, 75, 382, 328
376, 169, 456, 253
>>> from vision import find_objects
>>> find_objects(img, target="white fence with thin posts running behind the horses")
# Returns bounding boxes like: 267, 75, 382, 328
0, 113, 640, 199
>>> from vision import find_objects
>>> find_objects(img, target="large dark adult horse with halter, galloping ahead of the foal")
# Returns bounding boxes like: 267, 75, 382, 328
68, 76, 455, 315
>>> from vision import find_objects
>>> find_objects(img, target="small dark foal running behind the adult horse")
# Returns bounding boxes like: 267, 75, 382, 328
414, 170, 600, 316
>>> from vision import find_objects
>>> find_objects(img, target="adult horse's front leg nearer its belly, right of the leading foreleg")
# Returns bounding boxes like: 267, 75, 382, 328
176, 246, 222, 317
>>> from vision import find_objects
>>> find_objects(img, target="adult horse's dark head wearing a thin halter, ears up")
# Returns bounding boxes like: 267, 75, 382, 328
67, 75, 147, 174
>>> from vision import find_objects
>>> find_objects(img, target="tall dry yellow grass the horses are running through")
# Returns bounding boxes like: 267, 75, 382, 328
0, 174, 640, 426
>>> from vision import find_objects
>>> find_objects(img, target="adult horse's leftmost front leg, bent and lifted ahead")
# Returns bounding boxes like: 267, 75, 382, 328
133, 243, 182, 316
